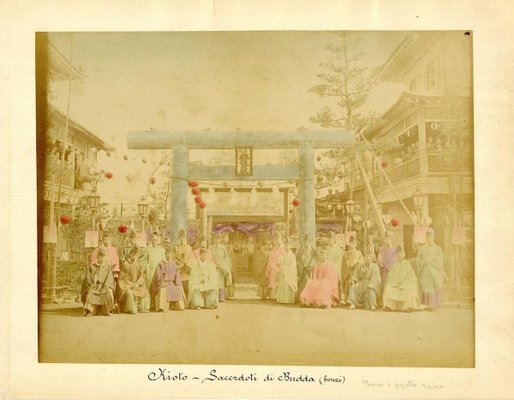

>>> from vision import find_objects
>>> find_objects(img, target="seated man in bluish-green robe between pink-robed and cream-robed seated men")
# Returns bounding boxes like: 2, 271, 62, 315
348, 254, 381, 311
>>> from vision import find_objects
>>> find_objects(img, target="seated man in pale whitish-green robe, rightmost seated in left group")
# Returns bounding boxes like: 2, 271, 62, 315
188, 247, 218, 310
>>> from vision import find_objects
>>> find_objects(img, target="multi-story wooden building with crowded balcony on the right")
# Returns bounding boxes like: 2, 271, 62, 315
353, 32, 474, 296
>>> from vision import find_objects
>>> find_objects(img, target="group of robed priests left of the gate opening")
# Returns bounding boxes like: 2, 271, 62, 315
81, 230, 234, 316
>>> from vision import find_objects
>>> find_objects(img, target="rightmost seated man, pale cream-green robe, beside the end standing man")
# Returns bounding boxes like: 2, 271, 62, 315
384, 246, 419, 311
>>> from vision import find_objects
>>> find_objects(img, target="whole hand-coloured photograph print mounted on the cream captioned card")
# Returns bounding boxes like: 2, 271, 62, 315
35, 31, 475, 368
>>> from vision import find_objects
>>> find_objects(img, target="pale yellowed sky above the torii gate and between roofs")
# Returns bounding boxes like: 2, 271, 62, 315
49, 31, 406, 205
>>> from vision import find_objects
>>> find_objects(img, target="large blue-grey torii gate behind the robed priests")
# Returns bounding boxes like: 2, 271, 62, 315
127, 130, 355, 241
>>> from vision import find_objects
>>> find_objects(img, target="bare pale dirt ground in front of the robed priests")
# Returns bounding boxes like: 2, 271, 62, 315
39, 284, 474, 367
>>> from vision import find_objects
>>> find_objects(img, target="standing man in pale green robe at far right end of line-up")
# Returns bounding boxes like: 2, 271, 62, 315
416, 228, 444, 311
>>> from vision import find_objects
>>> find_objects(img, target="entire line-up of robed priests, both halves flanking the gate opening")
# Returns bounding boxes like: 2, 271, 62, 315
82, 228, 444, 316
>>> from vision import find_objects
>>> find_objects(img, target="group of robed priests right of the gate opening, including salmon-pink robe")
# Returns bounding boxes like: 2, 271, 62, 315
255, 228, 444, 311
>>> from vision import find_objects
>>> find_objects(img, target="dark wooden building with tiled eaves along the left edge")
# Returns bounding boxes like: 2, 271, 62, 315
36, 35, 112, 295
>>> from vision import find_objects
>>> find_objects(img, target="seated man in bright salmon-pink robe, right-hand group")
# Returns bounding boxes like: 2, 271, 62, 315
300, 248, 339, 308
